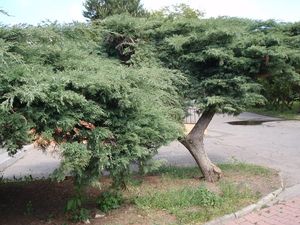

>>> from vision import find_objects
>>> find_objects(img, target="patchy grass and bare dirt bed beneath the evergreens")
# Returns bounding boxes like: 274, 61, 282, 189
0, 163, 280, 225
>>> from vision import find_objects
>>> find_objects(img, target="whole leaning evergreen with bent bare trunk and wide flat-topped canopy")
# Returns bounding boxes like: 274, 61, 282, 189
96, 12, 299, 181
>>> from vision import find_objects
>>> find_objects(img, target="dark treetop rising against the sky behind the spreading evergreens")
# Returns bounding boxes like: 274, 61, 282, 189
83, 0, 146, 20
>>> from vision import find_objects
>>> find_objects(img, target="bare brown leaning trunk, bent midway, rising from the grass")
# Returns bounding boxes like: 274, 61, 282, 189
181, 109, 222, 182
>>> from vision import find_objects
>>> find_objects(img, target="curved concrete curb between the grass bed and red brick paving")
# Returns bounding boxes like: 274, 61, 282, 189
204, 175, 285, 225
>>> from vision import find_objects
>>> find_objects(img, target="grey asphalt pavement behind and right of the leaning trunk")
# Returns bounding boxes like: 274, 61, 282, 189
156, 113, 300, 186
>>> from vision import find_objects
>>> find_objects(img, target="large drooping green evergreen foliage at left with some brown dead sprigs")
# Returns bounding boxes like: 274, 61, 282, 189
0, 24, 185, 186
